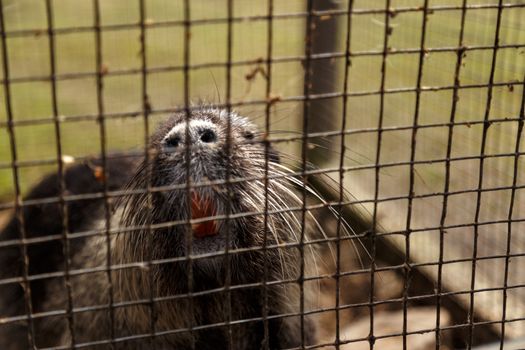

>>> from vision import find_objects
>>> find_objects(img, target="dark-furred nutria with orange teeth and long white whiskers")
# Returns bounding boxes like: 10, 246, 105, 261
0, 107, 319, 349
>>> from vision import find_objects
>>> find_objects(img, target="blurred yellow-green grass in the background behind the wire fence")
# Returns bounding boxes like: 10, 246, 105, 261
0, 0, 525, 199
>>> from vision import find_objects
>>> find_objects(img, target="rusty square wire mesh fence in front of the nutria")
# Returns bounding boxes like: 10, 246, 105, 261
0, 0, 525, 350
